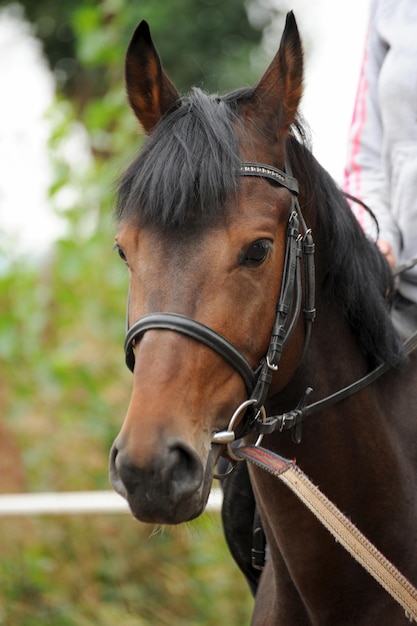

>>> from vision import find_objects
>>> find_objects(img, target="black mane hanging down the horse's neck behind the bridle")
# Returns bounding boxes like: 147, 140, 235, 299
289, 132, 405, 367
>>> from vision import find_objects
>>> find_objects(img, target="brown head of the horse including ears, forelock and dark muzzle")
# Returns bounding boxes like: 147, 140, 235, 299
110, 13, 304, 523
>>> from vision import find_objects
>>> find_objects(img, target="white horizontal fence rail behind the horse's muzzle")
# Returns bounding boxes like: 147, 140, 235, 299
0, 489, 222, 517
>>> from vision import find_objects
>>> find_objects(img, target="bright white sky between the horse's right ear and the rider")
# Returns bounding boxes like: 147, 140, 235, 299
282, 0, 369, 177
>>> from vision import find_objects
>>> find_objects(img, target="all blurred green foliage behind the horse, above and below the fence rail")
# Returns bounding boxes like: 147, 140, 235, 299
0, 0, 282, 626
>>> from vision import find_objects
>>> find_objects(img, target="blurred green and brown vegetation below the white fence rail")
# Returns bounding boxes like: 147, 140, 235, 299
0, 514, 253, 626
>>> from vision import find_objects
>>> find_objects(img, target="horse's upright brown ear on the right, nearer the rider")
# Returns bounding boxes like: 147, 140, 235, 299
254, 11, 303, 136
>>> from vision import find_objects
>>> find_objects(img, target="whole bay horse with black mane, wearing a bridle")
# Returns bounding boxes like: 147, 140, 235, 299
110, 13, 417, 626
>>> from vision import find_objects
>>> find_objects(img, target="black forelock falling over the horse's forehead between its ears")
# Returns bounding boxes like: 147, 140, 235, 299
116, 89, 240, 228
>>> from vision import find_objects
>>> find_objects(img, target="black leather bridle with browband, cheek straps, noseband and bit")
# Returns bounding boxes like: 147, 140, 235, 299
124, 158, 316, 446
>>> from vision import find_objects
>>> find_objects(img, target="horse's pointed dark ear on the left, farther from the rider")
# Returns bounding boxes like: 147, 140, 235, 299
125, 21, 179, 133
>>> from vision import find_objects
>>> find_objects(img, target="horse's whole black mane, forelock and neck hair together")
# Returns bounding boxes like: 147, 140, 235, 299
116, 89, 404, 366
